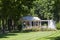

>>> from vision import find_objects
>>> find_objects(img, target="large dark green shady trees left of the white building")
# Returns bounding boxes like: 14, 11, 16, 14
0, 0, 35, 31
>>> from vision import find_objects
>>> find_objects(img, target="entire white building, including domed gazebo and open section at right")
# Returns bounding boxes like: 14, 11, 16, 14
22, 16, 56, 29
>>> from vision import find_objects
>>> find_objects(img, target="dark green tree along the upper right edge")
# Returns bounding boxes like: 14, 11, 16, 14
54, 0, 60, 22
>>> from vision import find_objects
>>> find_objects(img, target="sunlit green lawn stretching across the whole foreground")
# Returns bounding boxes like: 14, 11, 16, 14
0, 31, 60, 40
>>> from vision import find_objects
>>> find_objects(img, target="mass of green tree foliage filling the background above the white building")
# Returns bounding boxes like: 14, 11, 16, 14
0, 0, 60, 30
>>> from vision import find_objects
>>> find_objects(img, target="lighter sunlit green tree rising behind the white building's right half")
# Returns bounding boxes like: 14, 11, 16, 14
34, 0, 55, 19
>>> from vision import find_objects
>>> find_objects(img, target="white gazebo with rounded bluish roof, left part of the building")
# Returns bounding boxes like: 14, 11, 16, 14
22, 16, 41, 28
